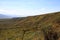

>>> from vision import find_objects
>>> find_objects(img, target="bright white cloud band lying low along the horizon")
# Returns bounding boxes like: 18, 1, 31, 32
0, 8, 54, 16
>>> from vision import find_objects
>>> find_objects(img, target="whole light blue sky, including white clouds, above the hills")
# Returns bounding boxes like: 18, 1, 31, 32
0, 0, 60, 16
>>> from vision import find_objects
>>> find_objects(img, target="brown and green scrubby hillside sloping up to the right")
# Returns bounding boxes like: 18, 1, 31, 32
0, 12, 60, 40
